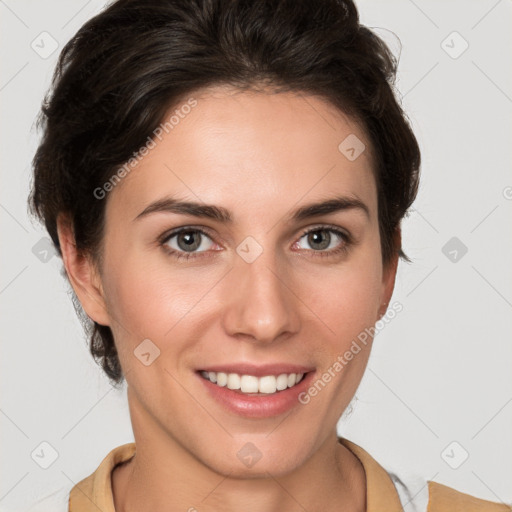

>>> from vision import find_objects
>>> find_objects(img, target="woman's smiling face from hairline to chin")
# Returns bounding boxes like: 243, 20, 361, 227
68, 87, 396, 477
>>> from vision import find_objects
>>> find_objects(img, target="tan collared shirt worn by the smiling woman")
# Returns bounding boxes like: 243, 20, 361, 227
33, 438, 512, 512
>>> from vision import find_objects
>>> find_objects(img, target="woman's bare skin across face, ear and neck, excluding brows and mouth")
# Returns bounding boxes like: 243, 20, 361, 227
58, 86, 399, 512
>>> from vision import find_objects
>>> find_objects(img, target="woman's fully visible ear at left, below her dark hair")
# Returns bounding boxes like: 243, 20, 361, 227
57, 213, 110, 325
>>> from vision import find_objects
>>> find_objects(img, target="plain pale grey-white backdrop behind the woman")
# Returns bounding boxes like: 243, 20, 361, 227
0, 0, 512, 510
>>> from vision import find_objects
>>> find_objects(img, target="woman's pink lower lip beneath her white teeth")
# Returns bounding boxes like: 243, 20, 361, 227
197, 371, 315, 418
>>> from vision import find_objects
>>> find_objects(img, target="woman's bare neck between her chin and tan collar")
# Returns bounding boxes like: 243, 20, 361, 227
112, 394, 366, 512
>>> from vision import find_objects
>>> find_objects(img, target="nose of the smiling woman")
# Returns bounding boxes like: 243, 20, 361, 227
223, 244, 300, 344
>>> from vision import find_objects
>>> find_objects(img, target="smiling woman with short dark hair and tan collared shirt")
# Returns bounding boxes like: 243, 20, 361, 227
30, 0, 509, 512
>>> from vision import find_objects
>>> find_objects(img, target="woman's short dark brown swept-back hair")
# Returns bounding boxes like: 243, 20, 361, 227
29, 0, 420, 384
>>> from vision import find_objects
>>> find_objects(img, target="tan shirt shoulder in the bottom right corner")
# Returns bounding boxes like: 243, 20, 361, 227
427, 480, 512, 512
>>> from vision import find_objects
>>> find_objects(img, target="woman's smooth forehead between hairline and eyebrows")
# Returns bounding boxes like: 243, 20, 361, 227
107, 86, 376, 223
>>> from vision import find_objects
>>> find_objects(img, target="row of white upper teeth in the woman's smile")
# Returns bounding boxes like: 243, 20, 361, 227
201, 371, 304, 395
